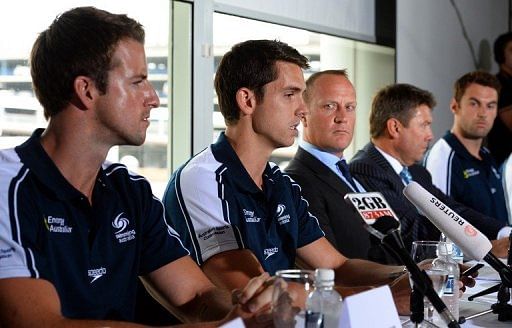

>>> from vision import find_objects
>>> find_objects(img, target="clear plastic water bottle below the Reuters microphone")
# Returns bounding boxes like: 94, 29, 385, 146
432, 242, 460, 319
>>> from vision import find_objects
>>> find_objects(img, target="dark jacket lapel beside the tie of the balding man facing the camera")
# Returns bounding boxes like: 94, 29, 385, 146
295, 147, 354, 196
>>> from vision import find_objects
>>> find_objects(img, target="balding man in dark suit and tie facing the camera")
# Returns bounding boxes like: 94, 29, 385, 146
285, 70, 393, 263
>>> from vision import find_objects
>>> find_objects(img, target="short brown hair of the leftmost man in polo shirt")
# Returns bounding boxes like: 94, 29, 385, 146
30, 7, 144, 118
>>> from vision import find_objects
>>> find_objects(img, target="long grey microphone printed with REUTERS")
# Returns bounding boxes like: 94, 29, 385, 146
403, 181, 512, 287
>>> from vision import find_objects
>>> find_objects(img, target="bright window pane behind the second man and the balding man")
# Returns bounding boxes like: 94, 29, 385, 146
213, 13, 395, 168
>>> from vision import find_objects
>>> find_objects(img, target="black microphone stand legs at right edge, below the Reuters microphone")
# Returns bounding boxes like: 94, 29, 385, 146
466, 233, 512, 321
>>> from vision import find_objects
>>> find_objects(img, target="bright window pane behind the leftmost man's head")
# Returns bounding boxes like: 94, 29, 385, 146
0, 0, 170, 196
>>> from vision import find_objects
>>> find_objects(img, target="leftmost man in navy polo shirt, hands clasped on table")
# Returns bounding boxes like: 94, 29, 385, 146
0, 7, 276, 327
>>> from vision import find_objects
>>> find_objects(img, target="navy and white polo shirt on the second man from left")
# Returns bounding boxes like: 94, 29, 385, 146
164, 133, 324, 274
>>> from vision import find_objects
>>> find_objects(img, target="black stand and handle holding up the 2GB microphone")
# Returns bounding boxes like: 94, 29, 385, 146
382, 229, 460, 328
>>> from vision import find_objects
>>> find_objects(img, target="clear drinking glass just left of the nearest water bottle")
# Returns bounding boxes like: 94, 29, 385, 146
272, 269, 315, 328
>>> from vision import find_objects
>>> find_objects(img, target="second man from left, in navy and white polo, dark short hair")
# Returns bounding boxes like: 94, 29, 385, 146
164, 40, 416, 313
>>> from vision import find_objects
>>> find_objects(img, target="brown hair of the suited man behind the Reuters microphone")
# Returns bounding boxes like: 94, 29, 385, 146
370, 83, 436, 138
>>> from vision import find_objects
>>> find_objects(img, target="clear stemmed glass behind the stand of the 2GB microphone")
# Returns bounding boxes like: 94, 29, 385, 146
409, 241, 448, 326
